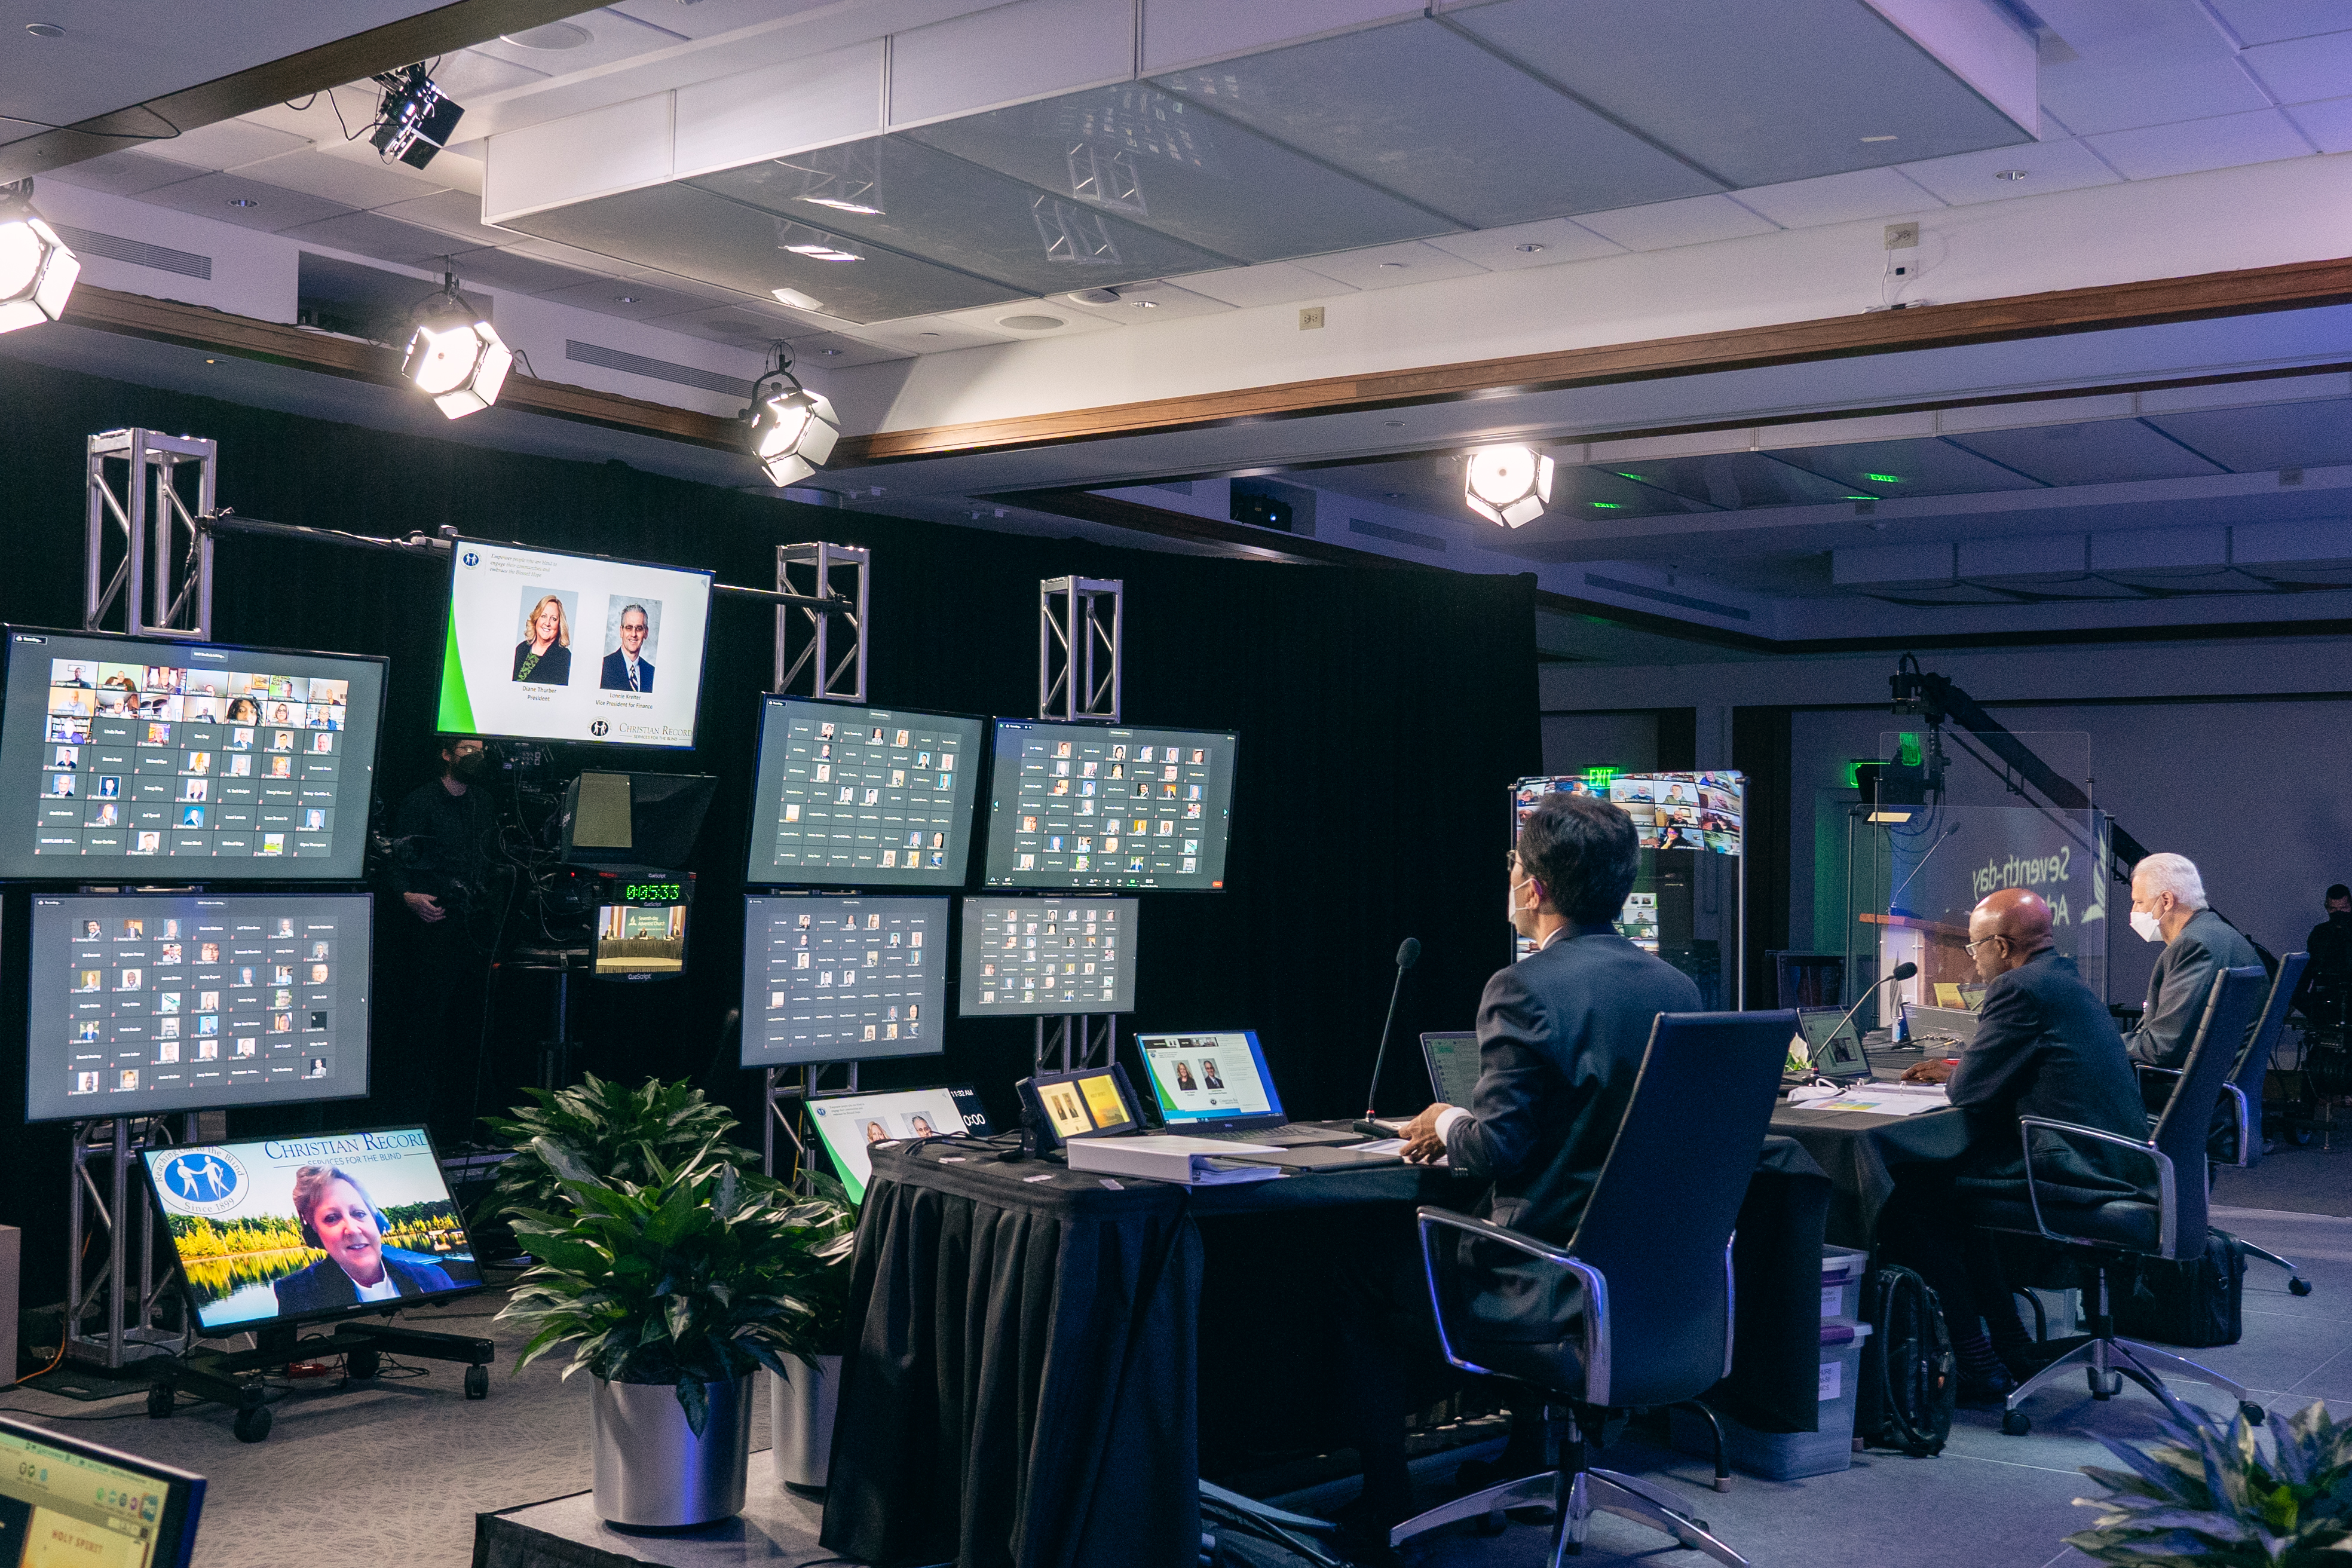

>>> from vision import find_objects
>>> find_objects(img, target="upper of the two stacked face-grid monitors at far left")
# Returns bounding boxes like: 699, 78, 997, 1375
0, 625, 384, 881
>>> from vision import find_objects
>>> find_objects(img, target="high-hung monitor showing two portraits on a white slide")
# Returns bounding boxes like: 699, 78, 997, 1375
437, 538, 710, 748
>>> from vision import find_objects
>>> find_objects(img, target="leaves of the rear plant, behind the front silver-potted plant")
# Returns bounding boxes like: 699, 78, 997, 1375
482, 1072, 760, 1220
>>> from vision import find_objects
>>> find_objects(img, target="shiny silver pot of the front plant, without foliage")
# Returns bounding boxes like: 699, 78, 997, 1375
595, 1373, 751, 1528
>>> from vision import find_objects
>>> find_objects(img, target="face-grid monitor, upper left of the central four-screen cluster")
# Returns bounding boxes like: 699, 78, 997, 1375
743, 696, 988, 889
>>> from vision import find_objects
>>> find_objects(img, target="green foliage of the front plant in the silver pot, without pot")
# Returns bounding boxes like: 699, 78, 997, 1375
498, 1138, 856, 1437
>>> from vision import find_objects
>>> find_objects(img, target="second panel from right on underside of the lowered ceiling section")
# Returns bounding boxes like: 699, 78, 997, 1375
1155, 21, 1722, 228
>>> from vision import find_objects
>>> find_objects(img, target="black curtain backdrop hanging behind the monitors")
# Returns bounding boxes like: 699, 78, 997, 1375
0, 362, 1541, 1302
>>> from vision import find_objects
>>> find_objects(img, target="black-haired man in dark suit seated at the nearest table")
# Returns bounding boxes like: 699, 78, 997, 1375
1341, 795, 1698, 1538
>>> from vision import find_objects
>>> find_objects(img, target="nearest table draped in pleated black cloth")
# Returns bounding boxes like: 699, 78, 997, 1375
823, 1138, 1832, 1568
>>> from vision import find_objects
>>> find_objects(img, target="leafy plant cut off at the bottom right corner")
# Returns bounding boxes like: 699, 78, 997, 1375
2065, 1404, 2352, 1568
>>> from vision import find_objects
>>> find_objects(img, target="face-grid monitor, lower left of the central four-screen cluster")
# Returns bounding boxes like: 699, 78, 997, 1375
743, 896, 948, 1067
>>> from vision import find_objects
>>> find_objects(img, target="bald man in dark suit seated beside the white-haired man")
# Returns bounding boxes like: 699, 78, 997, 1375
1879, 889, 2148, 1401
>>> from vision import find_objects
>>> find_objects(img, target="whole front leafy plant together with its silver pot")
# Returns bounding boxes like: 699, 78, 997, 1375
498, 1138, 854, 1528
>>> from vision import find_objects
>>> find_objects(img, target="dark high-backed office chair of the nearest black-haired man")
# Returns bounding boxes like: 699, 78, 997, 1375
1388, 1009, 1797, 1568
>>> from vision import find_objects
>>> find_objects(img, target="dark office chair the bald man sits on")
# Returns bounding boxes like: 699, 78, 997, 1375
1976, 964, 2270, 1437
